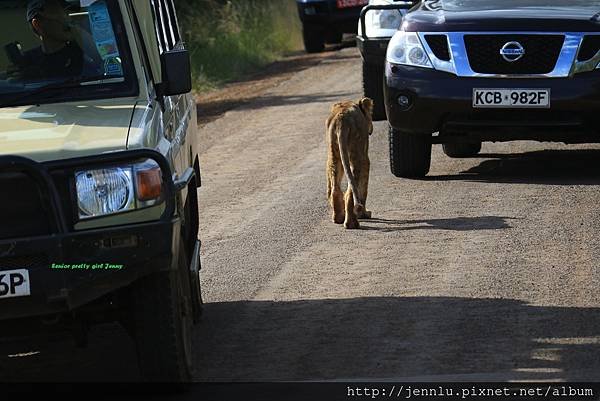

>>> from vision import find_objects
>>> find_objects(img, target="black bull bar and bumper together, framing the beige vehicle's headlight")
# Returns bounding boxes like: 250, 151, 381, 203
0, 150, 193, 320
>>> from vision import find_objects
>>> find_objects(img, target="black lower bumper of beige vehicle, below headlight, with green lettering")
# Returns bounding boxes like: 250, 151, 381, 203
0, 219, 180, 320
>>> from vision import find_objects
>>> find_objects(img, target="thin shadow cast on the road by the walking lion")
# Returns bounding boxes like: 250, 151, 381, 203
361, 216, 515, 232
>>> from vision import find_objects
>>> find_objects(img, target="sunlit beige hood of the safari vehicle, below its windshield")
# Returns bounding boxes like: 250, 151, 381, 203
0, 99, 135, 162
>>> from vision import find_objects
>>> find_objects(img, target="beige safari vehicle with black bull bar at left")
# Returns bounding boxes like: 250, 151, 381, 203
0, 0, 202, 381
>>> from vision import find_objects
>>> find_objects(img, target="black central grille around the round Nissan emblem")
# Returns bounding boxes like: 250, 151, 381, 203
464, 35, 565, 75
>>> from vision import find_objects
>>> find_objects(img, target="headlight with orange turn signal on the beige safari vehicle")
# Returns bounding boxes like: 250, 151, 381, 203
75, 160, 163, 219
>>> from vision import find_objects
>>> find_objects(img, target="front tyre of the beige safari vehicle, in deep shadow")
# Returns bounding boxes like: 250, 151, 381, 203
132, 248, 193, 382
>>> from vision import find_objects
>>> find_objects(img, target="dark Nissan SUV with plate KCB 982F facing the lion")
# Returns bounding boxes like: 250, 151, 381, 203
384, 0, 600, 177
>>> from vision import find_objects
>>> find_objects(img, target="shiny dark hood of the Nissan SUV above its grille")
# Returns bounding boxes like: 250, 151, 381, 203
403, 0, 600, 32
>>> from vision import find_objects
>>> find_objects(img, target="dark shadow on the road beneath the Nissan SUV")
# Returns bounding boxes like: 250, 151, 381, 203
425, 149, 600, 185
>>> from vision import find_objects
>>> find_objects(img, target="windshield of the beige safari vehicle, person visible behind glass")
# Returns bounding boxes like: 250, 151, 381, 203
0, 0, 132, 107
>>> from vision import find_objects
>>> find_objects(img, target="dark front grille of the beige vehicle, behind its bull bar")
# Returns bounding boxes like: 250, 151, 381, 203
0, 173, 52, 240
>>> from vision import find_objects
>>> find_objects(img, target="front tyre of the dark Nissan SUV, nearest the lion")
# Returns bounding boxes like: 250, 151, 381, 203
389, 123, 431, 178
